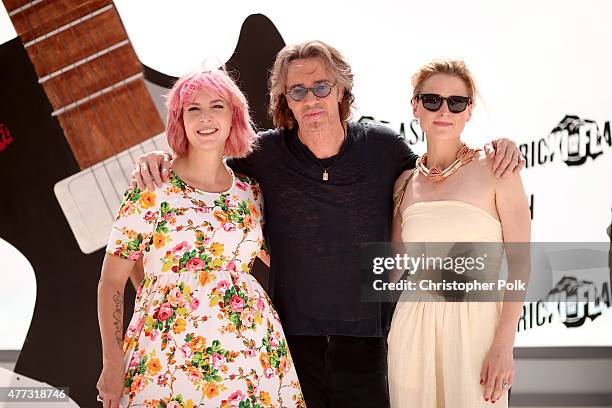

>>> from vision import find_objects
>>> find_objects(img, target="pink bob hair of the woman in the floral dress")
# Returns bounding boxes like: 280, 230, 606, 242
166, 69, 257, 157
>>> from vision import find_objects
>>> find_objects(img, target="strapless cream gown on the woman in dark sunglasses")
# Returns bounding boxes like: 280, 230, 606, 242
388, 200, 508, 408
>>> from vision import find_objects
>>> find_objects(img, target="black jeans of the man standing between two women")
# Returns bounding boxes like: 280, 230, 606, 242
287, 336, 389, 408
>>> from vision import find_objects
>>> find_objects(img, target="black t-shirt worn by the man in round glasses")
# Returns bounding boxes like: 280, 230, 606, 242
228, 123, 418, 336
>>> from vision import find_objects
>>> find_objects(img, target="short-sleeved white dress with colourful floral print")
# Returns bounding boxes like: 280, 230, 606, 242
107, 167, 305, 408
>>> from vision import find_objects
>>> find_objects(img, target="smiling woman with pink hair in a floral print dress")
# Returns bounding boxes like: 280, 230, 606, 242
97, 70, 304, 408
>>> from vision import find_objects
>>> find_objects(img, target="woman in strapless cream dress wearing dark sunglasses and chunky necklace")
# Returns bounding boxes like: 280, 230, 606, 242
388, 61, 530, 408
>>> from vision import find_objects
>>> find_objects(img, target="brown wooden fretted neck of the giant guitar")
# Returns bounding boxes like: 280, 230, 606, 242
3, 0, 164, 169
